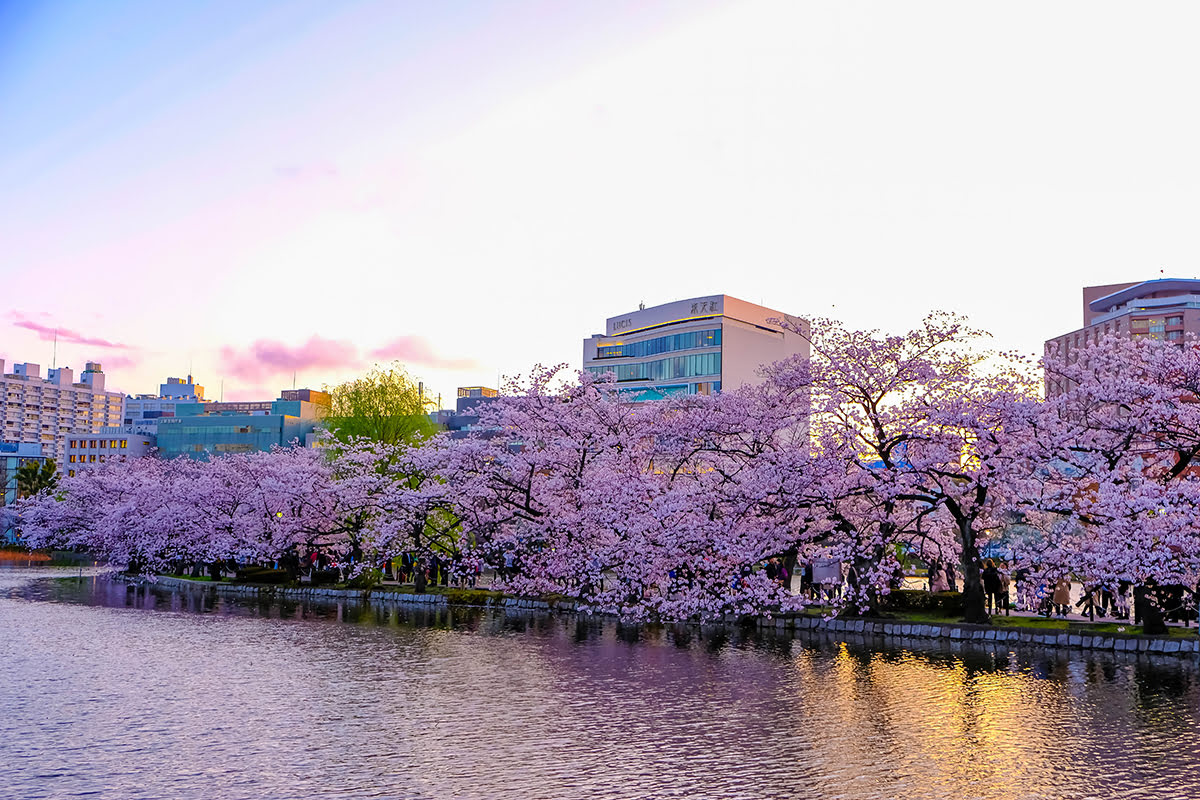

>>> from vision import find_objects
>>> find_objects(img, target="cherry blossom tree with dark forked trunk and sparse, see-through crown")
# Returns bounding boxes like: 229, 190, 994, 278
768, 313, 1033, 621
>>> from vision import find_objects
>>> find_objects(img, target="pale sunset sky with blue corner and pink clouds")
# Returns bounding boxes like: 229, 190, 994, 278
0, 0, 1200, 405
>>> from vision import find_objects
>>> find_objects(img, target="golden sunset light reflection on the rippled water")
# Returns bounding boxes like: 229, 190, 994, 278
793, 643, 1152, 800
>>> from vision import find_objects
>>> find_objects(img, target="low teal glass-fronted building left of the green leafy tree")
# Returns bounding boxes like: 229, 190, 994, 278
157, 389, 329, 458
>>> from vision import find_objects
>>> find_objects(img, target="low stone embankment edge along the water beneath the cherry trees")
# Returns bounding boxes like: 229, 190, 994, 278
124, 573, 1200, 658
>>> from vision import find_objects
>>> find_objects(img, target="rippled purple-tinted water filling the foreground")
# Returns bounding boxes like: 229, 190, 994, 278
0, 567, 1200, 800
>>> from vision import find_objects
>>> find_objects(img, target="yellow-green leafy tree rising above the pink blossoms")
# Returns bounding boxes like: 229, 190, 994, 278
325, 362, 437, 445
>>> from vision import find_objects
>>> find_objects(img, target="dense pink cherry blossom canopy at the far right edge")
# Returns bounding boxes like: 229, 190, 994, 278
1021, 336, 1200, 599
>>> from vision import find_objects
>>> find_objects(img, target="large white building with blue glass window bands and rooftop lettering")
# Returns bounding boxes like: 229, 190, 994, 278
583, 295, 809, 401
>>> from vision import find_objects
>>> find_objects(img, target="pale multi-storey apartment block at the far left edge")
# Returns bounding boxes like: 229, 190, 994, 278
0, 359, 125, 470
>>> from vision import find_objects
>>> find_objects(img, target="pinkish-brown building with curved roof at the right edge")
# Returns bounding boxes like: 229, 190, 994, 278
1045, 278, 1200, 395
